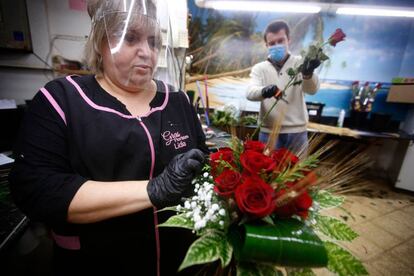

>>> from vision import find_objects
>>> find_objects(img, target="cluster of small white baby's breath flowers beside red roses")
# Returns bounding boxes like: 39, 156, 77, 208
176, 172, 226, 231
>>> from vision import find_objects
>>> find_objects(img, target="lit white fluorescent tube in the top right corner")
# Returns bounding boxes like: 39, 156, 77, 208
336, 7, 414, 17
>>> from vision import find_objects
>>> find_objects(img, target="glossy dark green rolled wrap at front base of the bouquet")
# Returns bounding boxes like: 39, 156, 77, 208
229, 219, 328, 267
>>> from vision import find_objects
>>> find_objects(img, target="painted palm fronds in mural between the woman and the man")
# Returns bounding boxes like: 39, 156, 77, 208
190, 10, 265, 74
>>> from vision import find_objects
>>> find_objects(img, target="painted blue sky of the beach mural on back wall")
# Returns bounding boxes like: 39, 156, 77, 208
189, 1, 414, 82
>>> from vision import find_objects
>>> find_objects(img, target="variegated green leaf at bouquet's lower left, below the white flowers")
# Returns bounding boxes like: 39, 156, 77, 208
179, 231, 233, 270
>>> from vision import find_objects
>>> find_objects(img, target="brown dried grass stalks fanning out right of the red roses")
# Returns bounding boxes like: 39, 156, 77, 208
274, 130, 371, 206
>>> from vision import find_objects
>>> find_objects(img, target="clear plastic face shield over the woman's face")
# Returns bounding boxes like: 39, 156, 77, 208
95, 0, 179, 89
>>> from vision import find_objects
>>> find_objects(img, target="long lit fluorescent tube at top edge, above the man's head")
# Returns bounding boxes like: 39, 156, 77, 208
196, 0, 321, 13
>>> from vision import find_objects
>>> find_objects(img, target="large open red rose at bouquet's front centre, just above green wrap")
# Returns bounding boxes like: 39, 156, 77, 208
234, 177, 275, 218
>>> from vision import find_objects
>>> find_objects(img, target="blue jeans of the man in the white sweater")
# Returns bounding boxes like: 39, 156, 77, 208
259, 131, 309, 153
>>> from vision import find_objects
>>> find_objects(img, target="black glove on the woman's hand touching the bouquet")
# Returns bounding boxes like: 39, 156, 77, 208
147, 149, 205, 208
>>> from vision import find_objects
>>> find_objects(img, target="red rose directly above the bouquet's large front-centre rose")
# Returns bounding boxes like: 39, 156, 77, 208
240, 150, 275, 174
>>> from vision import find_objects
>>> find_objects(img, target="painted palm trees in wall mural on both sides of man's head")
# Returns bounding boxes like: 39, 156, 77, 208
189, 5, 332, 80
